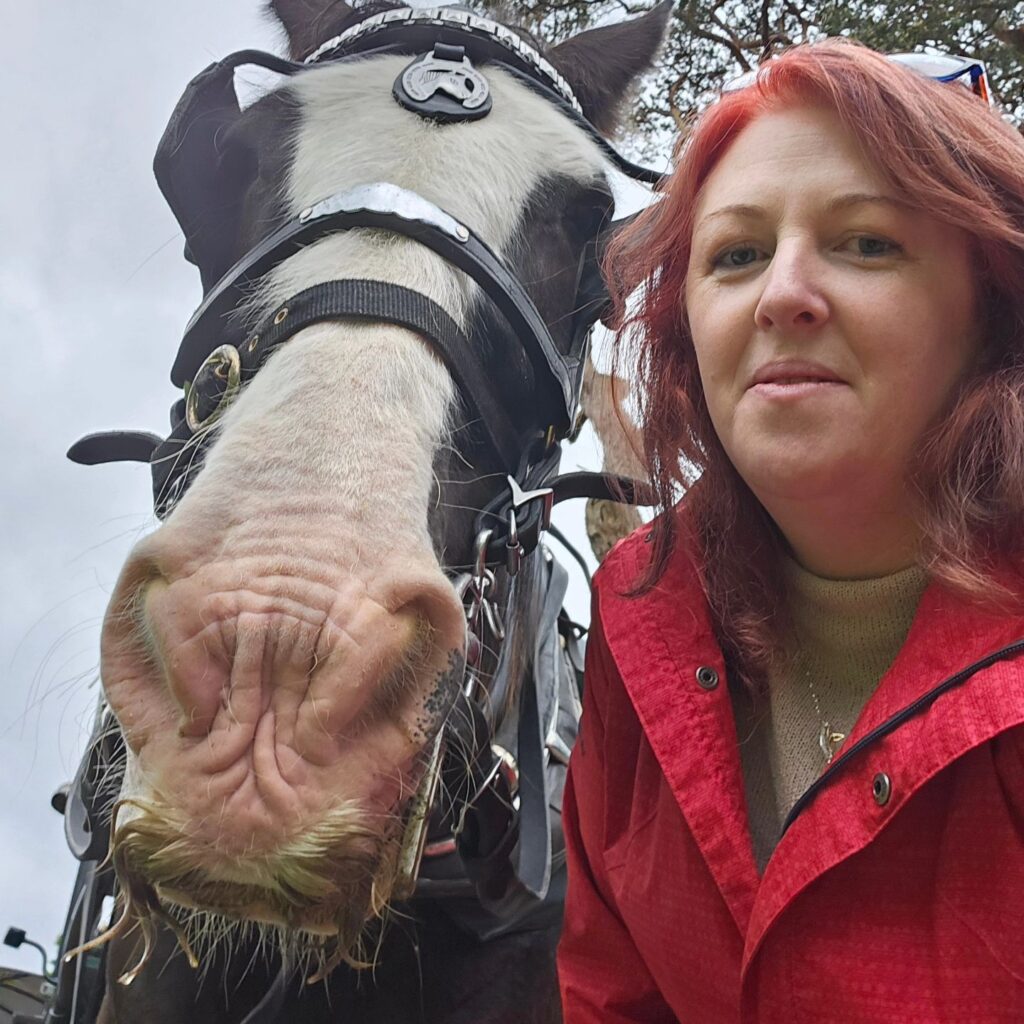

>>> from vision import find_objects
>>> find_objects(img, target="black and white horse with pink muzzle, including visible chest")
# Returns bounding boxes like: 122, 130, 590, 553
58, 0, 671, 1024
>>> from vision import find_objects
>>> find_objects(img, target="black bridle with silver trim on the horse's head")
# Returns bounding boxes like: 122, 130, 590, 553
58, 8, 660, 1015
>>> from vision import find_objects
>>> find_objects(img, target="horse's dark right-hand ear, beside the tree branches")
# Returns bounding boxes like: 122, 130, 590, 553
550, 0, 675, 135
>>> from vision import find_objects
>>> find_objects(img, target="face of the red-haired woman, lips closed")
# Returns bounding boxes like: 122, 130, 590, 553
685, 106, 980, 511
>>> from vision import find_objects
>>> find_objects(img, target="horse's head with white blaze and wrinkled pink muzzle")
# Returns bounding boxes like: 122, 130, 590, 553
83, 0, 669, 983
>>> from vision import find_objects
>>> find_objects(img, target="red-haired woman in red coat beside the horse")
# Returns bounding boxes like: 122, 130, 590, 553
560, 41, 1024, 1024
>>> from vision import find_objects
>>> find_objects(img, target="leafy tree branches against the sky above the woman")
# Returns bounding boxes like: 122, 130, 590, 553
472, 0, 1024, 150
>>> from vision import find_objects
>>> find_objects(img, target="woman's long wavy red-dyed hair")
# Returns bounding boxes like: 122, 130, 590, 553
606, 40, 1024, 682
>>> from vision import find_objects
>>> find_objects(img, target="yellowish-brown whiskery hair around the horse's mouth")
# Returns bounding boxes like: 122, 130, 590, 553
93, 800, 401, 984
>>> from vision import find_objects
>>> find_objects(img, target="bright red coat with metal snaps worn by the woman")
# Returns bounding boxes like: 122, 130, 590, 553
559, 532, 1024, 1024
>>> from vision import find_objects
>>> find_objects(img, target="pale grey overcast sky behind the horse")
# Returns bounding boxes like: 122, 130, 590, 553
0, 0, 651, 970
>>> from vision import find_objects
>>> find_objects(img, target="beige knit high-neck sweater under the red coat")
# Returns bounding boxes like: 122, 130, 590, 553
731, 561, 927, 871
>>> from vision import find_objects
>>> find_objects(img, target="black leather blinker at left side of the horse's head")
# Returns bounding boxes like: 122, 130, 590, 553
153, 61, 258, 292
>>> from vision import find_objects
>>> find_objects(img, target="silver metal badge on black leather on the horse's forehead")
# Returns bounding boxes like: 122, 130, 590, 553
392, 42, 494, 124
